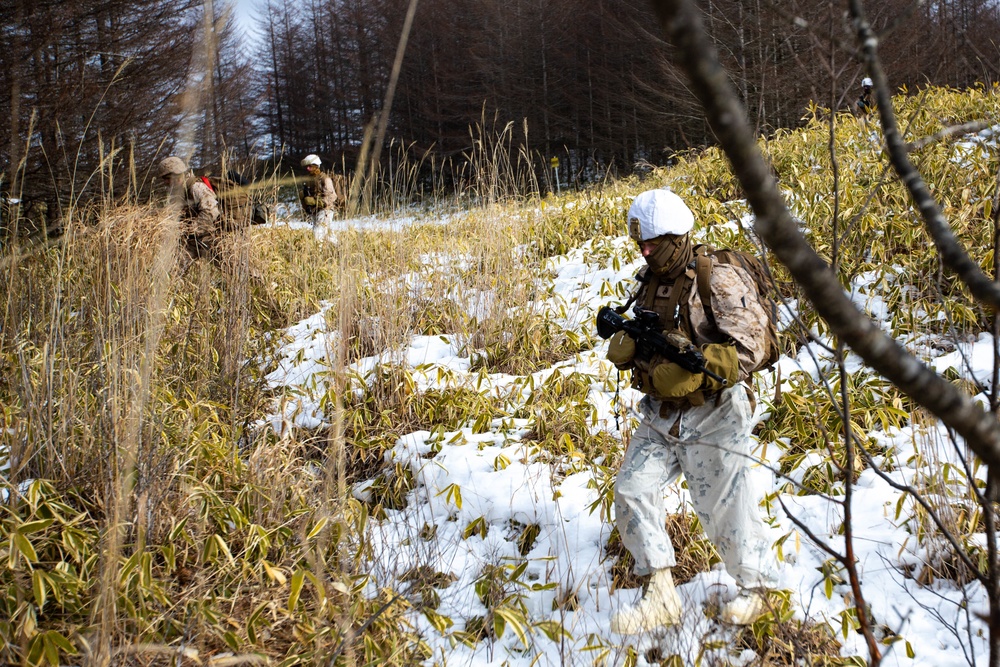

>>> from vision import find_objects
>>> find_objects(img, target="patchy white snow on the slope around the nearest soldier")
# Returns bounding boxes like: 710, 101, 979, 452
268, 207, 992, 667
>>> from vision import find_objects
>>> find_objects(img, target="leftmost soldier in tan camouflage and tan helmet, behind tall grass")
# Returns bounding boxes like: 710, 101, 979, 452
157, 155, 221, 260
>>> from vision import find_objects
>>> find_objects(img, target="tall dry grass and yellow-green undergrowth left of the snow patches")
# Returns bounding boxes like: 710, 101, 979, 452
0, 112, 608, 665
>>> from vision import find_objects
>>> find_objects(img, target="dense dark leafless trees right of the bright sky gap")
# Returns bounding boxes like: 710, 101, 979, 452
259, 0, 1000, 190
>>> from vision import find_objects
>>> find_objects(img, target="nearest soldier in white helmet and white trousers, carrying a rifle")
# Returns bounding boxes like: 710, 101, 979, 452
607, 189, 777, 634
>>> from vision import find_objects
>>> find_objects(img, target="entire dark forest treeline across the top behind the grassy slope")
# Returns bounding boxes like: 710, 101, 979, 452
0, 0, 1000, 227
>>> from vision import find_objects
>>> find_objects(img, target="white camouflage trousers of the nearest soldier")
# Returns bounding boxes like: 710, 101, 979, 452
615, 384, 777, 588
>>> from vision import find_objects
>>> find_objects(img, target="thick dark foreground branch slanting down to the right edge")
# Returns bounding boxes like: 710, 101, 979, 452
652, 0, 1000, 465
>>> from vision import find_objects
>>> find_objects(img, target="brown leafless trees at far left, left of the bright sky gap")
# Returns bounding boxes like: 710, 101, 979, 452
0, 0, 262, 237
